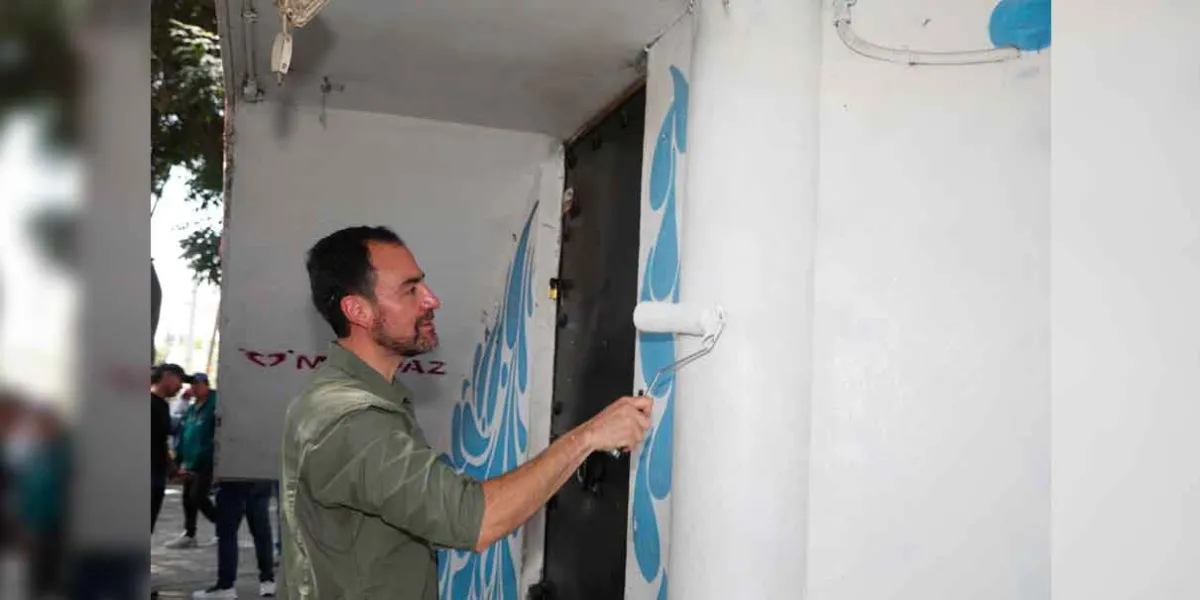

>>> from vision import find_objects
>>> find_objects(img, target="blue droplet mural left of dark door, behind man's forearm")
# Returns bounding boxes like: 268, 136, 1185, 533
438, 204, 538, 600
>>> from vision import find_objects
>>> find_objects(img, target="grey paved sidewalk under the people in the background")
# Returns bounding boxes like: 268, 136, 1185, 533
150, 486, 278, 600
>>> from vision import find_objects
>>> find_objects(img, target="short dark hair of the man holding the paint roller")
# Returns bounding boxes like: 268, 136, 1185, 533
306, 226, 404, 337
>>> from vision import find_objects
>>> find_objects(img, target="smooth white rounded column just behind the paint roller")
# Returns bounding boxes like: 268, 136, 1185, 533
668, 0, 823, 600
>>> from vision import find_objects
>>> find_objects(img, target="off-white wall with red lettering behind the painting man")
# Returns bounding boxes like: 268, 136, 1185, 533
217, 103, 563, 598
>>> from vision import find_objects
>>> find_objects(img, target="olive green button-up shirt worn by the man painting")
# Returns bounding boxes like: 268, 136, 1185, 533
281, 343, 484, 600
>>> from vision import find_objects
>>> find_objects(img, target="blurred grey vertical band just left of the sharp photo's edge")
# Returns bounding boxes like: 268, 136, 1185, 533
68, 0, 151, 599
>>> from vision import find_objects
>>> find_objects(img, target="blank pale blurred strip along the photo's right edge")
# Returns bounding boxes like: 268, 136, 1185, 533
1050, 0, 1200, 600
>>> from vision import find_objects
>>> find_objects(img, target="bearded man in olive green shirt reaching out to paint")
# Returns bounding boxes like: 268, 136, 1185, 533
281, 227, 653, 600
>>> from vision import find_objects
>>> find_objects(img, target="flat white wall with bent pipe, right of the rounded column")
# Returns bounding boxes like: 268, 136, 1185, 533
806, 0, 1050, 600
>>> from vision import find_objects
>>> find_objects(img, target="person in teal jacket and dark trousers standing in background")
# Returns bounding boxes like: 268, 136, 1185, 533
167, 373, 217, 548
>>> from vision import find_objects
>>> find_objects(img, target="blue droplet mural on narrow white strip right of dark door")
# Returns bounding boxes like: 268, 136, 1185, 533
632, 66, 688, 599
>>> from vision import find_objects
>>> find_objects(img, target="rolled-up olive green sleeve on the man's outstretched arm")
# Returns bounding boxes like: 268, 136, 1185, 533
300, 409, 484, 550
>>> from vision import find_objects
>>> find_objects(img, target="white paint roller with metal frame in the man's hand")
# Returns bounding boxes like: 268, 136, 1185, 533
608, 302, 725, 458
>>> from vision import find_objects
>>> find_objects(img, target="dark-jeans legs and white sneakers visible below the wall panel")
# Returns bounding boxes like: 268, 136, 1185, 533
192, 480, 275, 599
